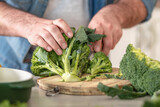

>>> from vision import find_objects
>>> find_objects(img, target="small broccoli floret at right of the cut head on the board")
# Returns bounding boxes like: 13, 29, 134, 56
87, 52, 112, 75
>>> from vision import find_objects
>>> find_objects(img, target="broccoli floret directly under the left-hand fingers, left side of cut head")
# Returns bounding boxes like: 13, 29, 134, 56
31, 47, 64, 76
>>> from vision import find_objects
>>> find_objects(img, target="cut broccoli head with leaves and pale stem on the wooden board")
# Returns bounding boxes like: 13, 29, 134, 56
31, 26, 112, 82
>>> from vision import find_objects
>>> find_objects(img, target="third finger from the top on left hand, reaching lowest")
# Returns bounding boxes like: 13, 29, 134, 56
40, 30, 62, 55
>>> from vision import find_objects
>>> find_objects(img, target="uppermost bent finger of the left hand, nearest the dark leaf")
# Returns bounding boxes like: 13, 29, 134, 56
53, 19, 73, 38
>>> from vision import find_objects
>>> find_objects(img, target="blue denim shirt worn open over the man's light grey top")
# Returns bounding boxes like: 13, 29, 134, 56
0, 0, 157, 71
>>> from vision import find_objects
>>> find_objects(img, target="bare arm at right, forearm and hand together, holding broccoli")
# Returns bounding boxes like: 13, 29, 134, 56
88, 0, 147, 55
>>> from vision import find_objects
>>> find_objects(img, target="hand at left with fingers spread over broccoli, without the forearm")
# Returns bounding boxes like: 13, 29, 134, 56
25, 19, 73, 55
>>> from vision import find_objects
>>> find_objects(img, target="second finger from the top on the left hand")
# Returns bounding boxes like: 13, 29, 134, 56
46, 25, 67, 49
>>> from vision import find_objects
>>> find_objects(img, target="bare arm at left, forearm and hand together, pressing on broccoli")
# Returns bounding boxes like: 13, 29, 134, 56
0, 2, 73, 55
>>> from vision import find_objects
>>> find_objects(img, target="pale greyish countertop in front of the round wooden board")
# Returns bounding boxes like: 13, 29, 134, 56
28, 79, 150, 107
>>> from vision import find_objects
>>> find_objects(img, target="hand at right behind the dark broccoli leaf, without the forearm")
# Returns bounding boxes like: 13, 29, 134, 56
88, 7, 122, 55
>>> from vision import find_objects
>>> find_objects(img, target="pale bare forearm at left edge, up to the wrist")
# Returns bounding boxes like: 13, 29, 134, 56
0, 2, 40, 37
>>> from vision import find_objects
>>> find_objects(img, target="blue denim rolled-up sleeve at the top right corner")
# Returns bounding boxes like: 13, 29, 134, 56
142, 0, 157, 21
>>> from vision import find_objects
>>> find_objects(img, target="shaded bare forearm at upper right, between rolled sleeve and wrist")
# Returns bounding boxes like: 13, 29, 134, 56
102, 0, 147, 28
